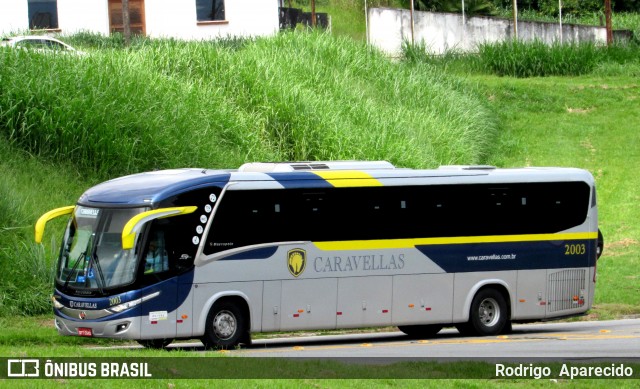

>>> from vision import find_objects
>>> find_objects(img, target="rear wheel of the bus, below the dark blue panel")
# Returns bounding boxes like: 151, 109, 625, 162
456, 288, 510, 336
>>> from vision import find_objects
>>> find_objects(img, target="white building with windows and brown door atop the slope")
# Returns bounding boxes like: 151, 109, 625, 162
0, 0, 280, 39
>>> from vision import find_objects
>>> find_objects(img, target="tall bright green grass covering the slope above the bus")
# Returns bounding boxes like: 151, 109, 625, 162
0, 33, 495, 176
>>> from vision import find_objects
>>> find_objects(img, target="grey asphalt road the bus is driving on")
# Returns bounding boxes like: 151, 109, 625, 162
94, 319, 640, 360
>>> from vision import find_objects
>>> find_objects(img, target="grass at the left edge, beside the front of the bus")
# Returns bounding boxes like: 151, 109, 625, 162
0, 142, 89, 316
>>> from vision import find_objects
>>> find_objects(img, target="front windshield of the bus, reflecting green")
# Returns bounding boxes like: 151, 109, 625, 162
56, 206, 147, 291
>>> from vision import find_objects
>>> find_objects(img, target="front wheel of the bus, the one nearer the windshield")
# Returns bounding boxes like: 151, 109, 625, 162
202, 301, 248, 349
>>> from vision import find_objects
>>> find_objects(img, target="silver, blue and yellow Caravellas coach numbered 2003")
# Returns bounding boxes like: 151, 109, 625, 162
36, 161, 603, 348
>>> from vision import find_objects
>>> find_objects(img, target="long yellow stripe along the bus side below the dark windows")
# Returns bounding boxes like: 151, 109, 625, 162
314, 232, 598, 251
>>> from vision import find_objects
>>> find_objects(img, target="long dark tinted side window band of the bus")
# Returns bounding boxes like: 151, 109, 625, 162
204, 182, 590, 254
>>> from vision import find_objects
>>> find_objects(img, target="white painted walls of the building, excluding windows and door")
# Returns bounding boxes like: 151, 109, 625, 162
0, 0, 279, 39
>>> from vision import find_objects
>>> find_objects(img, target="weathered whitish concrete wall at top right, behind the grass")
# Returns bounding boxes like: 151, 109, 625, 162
368, 8, 607, 55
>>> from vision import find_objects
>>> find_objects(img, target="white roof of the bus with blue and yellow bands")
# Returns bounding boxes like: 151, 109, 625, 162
78, 162, 593, 206
